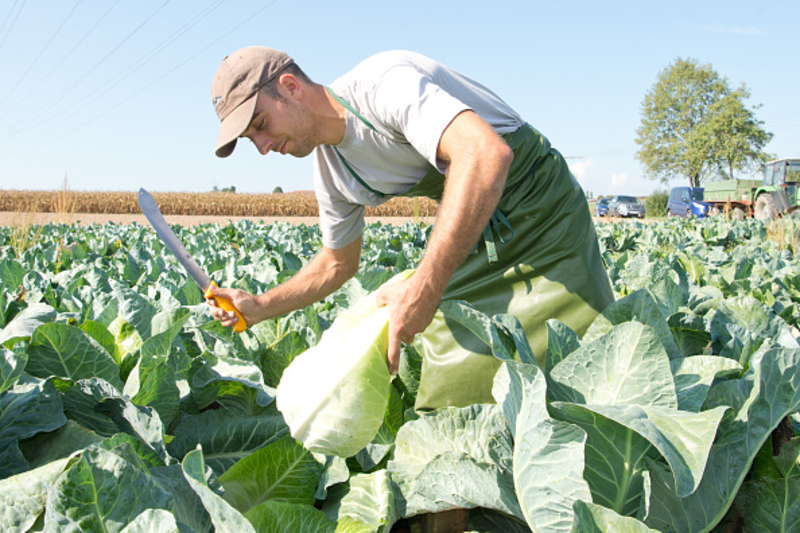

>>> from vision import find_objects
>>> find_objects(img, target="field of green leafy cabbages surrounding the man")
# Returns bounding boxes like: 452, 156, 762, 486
0, 217, 800, 533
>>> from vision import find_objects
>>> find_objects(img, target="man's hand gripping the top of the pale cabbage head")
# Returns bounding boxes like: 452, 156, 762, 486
376, 276, 439, 375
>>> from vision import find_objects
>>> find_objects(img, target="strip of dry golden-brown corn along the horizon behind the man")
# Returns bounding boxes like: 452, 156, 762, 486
0, 190, 436, 217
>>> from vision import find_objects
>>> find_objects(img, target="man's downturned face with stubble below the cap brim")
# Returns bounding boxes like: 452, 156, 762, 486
241, 87, 319, 157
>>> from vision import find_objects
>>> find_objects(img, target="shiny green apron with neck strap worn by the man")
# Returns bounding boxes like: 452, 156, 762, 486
324, 87, 614, 411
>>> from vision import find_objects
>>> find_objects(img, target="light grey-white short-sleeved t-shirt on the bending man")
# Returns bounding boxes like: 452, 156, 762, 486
314, 51, 523, 248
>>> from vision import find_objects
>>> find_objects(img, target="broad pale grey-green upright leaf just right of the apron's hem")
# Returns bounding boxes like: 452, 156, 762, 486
550, 322, 678, 408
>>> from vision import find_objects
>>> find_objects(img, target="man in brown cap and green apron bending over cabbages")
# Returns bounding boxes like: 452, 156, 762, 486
210, 47, 613, 410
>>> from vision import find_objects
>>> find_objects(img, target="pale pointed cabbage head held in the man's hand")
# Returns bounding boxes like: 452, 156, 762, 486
276, 271, 413, 457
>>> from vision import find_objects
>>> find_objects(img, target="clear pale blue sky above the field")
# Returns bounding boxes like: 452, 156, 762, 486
0, 0, 800, 196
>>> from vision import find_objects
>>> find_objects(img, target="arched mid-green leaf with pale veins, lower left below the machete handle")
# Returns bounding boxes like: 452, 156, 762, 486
25, 323, 123, 390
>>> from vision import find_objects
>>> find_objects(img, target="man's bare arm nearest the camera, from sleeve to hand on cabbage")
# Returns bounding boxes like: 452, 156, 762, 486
378, 111, 514, 373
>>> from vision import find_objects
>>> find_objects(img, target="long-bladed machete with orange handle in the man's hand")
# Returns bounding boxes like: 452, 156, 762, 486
139, 189, 247, 332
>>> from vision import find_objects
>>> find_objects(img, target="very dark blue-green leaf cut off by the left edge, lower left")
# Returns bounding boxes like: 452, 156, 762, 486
0, 377, 67, 479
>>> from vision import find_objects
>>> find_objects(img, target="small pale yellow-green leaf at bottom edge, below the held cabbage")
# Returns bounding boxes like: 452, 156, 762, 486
322, 470, 400, 533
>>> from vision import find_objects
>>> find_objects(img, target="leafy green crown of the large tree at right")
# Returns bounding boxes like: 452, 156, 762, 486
636, 58, 771, 187
